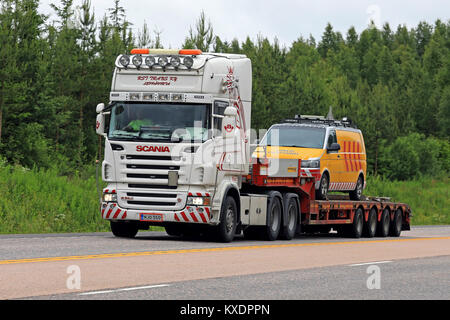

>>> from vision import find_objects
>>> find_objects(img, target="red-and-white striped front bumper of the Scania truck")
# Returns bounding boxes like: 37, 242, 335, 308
101, 202, 212, 224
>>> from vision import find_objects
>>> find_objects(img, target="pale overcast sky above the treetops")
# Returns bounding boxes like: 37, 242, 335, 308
40, 0, 450, 48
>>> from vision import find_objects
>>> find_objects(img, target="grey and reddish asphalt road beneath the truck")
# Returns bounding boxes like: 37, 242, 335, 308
0, 226, 450, 300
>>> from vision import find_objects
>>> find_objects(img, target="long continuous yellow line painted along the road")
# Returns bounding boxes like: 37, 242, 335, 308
0, 237, 450, 265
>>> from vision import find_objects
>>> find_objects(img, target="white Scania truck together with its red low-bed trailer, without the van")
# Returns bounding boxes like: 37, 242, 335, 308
96, 49, 411, 242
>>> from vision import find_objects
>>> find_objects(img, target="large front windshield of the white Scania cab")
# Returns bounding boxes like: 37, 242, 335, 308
108, 102, 210, 142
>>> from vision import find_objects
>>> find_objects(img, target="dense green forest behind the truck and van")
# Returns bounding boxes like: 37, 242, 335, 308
0, 0, 450, 183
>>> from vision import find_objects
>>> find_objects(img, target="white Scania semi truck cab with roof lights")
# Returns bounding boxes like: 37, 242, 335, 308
96, 49, 260, 241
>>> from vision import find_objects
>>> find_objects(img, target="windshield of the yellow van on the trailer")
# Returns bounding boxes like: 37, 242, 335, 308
260, 126, 325, 149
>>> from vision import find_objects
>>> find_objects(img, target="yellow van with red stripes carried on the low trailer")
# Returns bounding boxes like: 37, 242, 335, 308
253, 117, 367, 200
